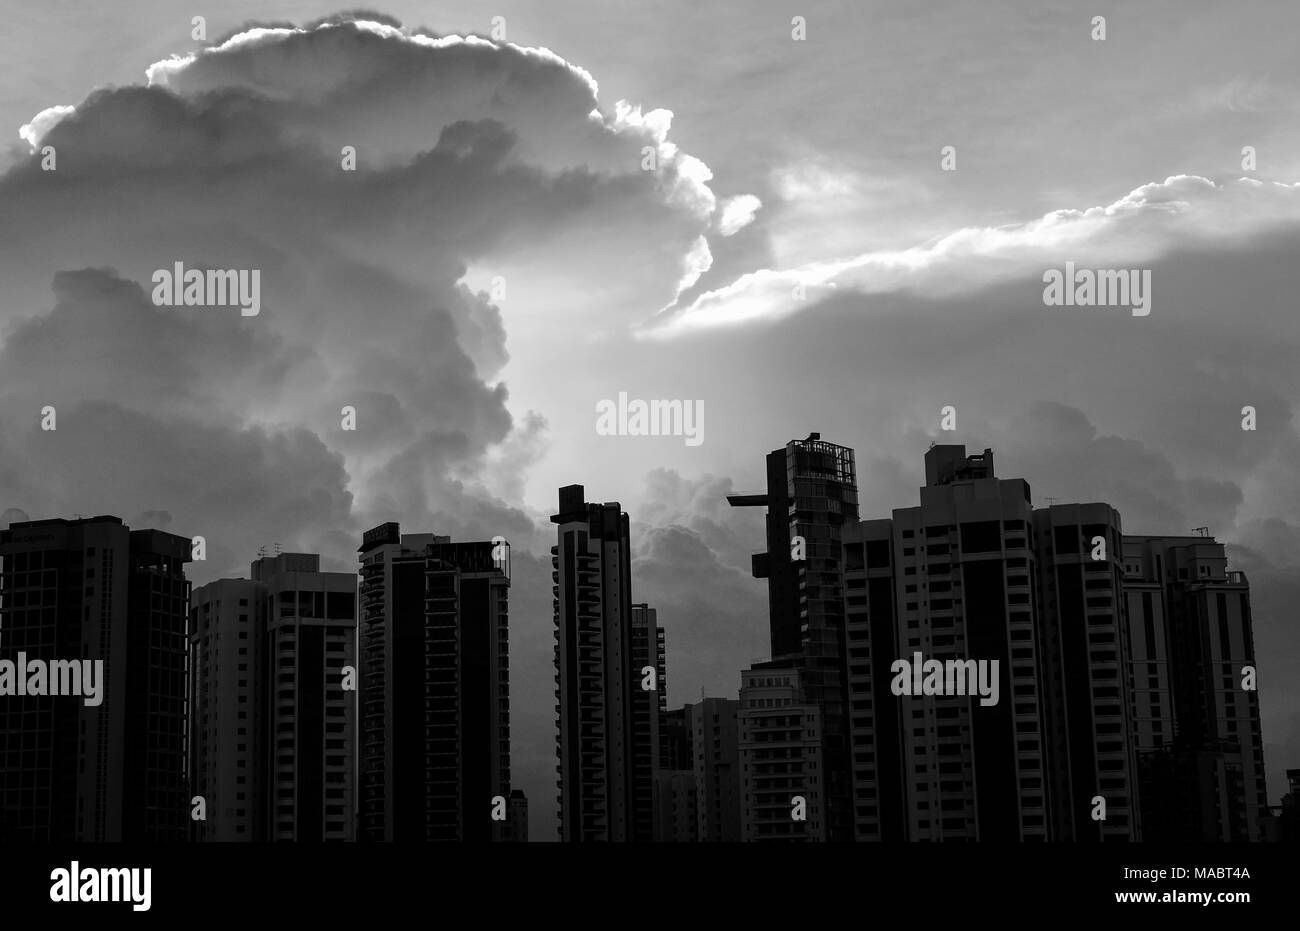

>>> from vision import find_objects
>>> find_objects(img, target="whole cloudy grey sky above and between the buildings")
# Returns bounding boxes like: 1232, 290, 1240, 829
0, 0, 1300, 837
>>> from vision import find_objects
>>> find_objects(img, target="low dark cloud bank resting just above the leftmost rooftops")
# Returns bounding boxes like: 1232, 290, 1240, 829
0, 400, 351, 577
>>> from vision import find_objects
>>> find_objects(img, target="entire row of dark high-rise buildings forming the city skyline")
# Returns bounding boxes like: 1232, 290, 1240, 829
0, 433, 1294, 843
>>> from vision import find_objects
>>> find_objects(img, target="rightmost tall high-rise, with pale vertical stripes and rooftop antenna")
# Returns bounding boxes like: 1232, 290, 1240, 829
1123, 534, 1268, 841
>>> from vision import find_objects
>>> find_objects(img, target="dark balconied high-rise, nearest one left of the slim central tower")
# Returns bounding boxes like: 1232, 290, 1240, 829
359, 521, 511, 841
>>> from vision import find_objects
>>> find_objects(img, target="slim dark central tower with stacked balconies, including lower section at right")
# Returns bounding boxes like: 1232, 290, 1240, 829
551, 485, 659, 841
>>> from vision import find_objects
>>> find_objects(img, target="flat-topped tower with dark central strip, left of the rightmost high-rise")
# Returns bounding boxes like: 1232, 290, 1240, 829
1034, 503, 1141, 841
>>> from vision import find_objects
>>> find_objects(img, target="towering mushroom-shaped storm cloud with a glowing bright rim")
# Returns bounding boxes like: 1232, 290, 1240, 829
0, 14, 733, 582
